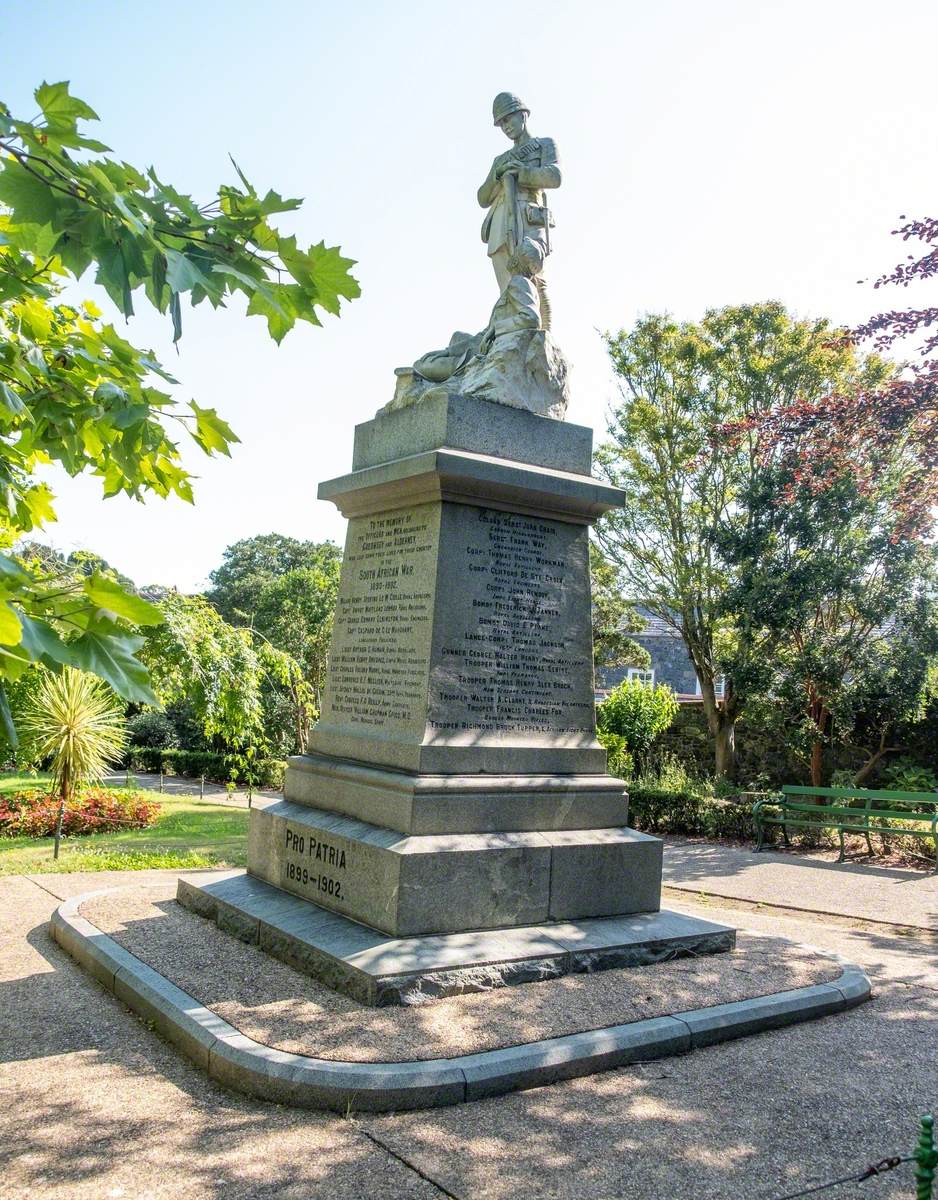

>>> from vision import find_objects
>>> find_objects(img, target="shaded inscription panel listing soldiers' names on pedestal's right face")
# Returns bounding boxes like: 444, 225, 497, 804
428, 505, 594, 742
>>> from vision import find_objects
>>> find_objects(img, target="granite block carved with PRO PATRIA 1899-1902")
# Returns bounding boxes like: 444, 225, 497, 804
247, 799, 661, 937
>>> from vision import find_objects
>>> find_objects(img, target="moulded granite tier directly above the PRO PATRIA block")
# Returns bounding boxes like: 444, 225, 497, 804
284, 754, 629, 834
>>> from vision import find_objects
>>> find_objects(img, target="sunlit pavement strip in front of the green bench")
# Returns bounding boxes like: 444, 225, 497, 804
665, 838, 938, 932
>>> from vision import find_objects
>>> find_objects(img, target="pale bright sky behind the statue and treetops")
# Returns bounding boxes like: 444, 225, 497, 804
0, 0, 938, 589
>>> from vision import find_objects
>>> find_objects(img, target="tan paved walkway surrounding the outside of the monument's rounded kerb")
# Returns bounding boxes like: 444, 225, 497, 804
0, 844, 938, 1200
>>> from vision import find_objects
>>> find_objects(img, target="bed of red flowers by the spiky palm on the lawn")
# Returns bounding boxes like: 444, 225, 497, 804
0, 787, 160, 838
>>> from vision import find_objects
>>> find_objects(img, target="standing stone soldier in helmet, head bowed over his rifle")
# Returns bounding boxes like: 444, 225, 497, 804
479, 91, 560, 329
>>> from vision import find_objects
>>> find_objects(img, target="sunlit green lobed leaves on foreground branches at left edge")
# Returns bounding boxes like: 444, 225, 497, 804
0, 83, 359, 738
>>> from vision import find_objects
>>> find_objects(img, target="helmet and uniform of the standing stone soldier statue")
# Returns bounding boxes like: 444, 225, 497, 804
479, 92, 560, 329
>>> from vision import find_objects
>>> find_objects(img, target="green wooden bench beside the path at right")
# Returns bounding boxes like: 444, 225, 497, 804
752, 784, 938, 874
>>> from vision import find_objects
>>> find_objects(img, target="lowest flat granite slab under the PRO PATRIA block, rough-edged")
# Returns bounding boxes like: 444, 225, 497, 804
178, 871, 735, 1006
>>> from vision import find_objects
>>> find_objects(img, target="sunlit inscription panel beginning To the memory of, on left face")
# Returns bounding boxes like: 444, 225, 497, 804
323, 504, 440, 736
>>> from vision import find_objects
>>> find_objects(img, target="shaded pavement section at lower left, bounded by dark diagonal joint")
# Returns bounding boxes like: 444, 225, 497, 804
0, 902, 439, 1200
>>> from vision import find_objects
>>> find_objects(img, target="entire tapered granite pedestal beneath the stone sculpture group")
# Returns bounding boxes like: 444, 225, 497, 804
180, 391, 733, 1003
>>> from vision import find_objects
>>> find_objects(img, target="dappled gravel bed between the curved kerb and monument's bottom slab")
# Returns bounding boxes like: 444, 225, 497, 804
82, 883, 841, 1062
